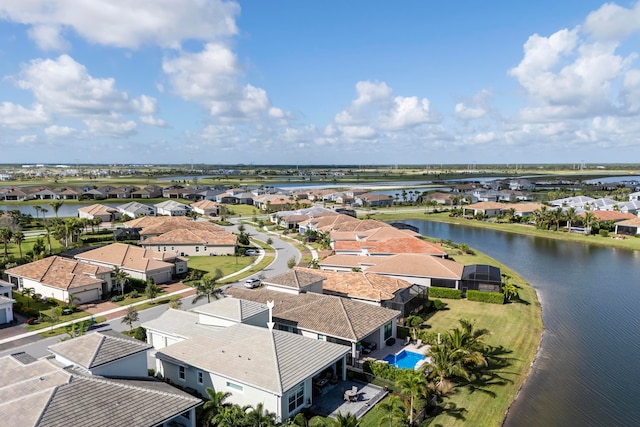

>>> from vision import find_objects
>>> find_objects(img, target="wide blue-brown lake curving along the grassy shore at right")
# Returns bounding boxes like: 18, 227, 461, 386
403, 220, 640, 427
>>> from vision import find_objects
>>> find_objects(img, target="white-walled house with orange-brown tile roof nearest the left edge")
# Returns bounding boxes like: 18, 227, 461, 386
5, 256, 112, 303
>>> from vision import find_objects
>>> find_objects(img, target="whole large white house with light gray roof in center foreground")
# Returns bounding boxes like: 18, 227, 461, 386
143, 304, 349, 422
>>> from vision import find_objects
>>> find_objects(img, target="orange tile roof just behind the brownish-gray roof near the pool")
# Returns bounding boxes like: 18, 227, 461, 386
296, 269, 411, 302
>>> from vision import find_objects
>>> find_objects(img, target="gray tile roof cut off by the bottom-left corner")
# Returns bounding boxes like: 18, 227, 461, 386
0, 356, 201, 427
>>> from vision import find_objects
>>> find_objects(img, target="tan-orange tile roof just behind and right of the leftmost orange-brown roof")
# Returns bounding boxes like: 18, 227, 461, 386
76, 243, 174, 271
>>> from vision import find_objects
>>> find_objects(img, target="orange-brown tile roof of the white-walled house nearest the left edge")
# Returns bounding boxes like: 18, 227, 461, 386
5, 256, 111, 289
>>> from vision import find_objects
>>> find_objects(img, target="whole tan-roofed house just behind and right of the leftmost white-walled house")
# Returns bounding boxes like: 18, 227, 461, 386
75, 243, 187, 284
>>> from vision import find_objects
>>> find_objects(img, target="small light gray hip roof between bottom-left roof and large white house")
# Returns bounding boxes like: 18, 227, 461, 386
49, 331, 151, 369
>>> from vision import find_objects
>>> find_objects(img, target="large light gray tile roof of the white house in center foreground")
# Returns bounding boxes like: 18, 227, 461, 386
156, 324, 350, 395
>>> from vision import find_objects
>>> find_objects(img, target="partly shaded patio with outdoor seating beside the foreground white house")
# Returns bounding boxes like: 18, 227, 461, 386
310, 380, 388, 418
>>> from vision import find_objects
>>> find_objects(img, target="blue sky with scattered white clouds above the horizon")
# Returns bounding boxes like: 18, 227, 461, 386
0, 0, 640, 165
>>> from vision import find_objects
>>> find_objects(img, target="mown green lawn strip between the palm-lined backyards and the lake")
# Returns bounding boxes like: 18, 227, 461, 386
427, 254, 543, 426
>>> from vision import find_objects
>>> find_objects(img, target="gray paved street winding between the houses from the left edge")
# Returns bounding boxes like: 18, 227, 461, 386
0, 224, 302, 358
